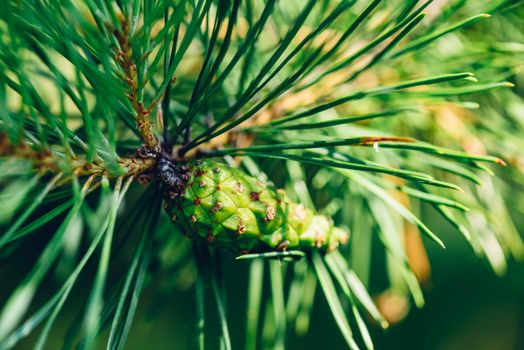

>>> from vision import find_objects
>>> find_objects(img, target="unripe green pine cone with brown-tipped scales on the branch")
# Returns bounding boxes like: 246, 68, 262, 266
160, 160, 348, 253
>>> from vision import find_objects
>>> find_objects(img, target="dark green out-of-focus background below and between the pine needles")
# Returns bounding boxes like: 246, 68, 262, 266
9, 202, 524, 350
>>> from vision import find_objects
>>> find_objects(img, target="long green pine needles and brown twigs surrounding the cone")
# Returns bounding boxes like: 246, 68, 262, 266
0, 0, 524, 349
